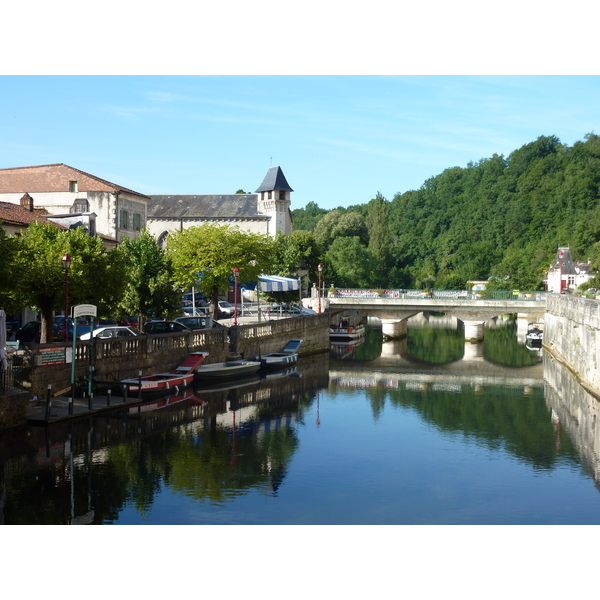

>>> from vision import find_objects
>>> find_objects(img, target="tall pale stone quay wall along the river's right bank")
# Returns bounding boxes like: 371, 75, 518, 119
543, 294, 600, 397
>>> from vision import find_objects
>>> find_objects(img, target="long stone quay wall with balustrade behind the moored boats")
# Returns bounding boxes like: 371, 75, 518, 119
7, 314, 329, 404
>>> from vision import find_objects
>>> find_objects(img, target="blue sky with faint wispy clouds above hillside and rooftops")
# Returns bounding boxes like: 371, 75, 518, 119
0, 75, 600, 209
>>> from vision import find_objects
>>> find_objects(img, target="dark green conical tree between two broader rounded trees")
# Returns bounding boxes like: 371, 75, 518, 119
117, 229, 181, 319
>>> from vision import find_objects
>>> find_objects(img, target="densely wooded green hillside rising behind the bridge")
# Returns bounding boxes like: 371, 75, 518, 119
292, 133, 600, 289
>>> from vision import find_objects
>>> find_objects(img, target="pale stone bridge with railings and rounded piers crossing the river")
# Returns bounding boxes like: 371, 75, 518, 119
327, 290, 547, 341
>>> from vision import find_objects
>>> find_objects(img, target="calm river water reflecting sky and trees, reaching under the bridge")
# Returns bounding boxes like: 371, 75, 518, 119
0, 316, 600, 525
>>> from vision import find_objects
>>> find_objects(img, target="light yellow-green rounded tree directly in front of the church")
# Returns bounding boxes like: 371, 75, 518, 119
167, 223, 273, 317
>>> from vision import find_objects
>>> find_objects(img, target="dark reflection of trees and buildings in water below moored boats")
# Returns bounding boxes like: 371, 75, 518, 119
0, 356, 328, 524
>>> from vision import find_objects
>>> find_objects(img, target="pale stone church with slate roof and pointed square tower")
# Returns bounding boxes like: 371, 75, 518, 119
148, 167, 294, 246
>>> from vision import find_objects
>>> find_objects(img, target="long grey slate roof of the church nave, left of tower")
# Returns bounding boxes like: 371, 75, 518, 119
147, 194, 269, 220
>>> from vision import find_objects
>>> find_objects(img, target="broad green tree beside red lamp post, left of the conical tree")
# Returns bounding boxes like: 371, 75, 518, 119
14, 222, 126, 343
